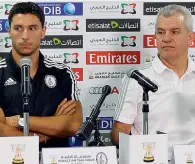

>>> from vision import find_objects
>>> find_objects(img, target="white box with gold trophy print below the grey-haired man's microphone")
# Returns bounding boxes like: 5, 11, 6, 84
119, 133, 168, 164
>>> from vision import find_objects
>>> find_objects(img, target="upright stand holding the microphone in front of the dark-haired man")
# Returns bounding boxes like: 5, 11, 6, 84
23, 96, 29, 136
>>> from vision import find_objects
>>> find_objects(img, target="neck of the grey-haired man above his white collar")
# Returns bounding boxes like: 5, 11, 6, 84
159, 55, 188, 78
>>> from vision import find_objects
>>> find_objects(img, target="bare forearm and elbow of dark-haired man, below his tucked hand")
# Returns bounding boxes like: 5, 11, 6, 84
29, 101, 83, 138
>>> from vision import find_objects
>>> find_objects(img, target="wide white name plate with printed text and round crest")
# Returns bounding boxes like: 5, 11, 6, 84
42, 146, 117, 164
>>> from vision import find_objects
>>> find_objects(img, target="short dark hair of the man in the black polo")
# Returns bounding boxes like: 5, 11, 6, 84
8, 2, 45, 28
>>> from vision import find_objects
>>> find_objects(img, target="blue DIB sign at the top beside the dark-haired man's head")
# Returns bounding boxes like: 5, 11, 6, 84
37, 2, 83, 16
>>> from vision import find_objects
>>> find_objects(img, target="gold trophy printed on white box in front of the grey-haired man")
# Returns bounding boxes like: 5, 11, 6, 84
143, 142, 155, 162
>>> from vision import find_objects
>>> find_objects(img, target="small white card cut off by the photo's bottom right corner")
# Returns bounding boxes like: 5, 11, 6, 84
173, 145, 195, 164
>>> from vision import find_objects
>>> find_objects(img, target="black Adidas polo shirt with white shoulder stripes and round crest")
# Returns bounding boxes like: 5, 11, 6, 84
0, 52, 78, 149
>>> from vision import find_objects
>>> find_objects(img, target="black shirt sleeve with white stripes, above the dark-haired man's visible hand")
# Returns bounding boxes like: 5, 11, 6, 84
60, 66, 79, 101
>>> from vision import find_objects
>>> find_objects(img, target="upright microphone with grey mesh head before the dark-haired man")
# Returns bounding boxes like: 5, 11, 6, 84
20, 57, 32, 97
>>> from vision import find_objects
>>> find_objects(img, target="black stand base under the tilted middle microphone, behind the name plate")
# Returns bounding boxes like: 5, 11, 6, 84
88, 119, 106, 146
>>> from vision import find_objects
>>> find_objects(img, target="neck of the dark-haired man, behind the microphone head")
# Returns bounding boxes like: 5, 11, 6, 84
12, 48, 39, 78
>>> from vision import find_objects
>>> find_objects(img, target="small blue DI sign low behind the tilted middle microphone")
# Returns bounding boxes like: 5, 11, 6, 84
86, 117, 113, 130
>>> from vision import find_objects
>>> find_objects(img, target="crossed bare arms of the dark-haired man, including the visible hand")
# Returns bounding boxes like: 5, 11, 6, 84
6, 99, 83, 138
